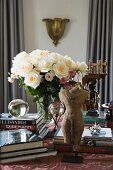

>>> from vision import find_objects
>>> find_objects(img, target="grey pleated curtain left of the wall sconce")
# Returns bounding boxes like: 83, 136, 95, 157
0, 0, 25, 113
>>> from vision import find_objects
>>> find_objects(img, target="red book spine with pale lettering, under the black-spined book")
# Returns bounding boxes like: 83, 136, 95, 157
0, 124, 37, 132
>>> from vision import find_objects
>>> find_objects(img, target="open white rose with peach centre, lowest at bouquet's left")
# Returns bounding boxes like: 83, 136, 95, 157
24, 71, 41, 89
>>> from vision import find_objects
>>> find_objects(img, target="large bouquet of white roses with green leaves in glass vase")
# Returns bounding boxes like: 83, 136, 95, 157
8, 49, 87, 118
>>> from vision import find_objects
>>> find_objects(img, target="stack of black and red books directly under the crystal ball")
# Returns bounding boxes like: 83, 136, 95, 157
0, 113, 46, 133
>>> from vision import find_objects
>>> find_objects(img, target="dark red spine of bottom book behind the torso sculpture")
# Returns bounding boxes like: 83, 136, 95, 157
54, 144, 113, 154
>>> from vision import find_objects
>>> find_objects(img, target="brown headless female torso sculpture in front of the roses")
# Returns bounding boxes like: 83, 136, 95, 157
59, 86, 89, 152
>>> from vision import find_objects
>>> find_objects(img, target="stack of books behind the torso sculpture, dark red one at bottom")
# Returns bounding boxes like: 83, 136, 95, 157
53, 127, 113, 154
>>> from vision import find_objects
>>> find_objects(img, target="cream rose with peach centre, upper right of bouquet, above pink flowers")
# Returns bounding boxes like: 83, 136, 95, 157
53, 62, 69, 78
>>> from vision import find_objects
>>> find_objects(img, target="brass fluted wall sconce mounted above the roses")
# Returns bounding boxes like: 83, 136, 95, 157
42, 18, 70, 46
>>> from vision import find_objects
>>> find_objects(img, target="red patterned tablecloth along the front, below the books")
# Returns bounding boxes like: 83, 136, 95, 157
0, 154, 113, 170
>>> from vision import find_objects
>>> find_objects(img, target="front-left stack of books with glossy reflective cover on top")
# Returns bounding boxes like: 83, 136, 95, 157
0, 129, 57, 163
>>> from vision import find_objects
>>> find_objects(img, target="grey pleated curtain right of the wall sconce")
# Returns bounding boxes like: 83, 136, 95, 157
87, 0, 113, 104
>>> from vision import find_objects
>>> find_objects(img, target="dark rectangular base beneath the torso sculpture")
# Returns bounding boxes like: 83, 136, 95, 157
61, 155, 83, 163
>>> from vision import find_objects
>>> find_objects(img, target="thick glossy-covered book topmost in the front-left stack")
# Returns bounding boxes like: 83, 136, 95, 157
0, 129, 43, 153
